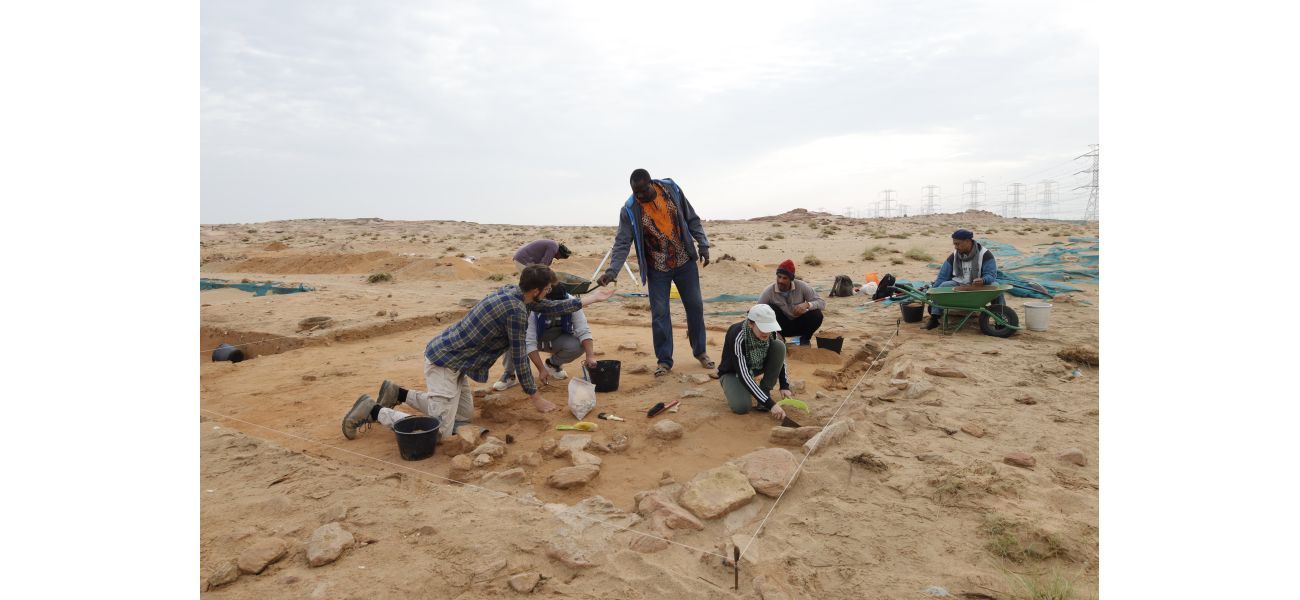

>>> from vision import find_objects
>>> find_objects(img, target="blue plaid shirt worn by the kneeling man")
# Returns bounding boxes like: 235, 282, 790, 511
424, 286, 582, 395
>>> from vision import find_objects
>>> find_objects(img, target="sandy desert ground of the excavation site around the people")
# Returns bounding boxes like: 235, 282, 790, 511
198, 212, 1100, 599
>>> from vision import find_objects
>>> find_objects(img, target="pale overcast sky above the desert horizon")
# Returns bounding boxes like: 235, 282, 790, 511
200, 0, 1100, 225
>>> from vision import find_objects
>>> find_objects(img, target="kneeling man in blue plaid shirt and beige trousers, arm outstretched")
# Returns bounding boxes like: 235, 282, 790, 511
343, 265, 614, 439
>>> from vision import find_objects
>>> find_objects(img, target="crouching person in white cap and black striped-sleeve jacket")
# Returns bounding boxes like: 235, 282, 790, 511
718, 304, 790, 418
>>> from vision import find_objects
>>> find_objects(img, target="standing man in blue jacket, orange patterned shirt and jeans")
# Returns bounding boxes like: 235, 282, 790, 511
599, 169, 716, 377
